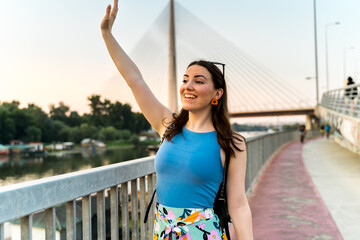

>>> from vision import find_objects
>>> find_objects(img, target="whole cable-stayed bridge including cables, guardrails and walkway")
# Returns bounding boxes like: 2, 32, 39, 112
0, 1, 360, 240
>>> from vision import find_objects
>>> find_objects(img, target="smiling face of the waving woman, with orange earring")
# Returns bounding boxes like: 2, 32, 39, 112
180, 65, 222, 111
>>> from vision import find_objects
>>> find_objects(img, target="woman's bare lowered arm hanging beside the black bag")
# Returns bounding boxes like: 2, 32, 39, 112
226, 139, 254, 240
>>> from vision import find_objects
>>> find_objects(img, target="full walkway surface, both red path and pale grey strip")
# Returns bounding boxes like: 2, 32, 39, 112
249, 138, 360, 240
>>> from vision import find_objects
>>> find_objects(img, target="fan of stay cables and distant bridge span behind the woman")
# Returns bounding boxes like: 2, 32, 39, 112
105, 2, 314, 117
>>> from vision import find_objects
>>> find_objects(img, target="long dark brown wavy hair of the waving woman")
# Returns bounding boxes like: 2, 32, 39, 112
164, 60, 245, 157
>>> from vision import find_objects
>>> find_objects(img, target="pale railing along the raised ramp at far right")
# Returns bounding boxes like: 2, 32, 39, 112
321, 84, 360, 117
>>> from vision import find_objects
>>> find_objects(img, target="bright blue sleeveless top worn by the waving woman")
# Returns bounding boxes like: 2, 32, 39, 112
155, 127, 223, 208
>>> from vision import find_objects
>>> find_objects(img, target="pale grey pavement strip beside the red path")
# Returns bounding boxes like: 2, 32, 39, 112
303, 138, 360, 240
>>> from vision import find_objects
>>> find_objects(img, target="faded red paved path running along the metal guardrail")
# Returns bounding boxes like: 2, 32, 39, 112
248, 138, 344, 240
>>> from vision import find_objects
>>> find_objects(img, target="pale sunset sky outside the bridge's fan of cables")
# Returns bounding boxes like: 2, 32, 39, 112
0, 0, 360, 124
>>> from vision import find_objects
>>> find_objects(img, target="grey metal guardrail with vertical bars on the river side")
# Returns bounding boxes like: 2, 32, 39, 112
0, 131, 318, 240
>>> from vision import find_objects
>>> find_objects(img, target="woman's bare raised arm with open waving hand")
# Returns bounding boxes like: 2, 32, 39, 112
101, 0, 172, 136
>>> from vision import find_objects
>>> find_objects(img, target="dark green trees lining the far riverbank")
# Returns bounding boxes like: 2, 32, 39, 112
0, 95, 150, 144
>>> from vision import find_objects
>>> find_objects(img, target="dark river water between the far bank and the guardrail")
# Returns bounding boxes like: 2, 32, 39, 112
0, 132, 266, 187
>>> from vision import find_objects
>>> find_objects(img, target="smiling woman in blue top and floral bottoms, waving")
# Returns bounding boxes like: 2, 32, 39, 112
101, 0, 253, 240
